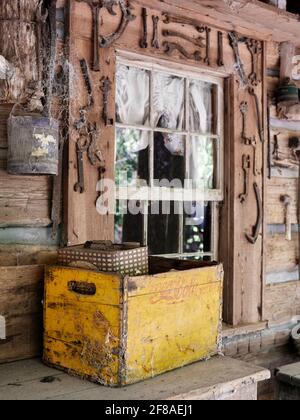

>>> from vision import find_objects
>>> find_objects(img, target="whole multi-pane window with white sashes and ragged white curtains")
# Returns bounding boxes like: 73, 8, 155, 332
115, 55, 224, 259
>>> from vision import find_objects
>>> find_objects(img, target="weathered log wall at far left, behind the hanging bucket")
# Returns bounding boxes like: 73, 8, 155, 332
0, 0, 61, 363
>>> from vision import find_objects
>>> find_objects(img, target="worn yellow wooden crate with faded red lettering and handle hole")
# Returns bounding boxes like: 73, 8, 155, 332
44, 265, 223, 386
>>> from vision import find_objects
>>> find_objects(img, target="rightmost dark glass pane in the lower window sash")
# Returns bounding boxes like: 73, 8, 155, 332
184, 203, 212, 253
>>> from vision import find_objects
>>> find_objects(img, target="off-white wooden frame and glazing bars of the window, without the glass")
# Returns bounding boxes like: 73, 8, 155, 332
114, 51, 227, 259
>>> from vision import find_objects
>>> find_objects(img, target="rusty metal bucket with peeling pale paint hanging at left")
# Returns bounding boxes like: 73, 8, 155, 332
7, 115, 59, 175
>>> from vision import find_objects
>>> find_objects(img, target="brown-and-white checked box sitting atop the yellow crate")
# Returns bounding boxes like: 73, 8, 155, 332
58, 241, 149, 276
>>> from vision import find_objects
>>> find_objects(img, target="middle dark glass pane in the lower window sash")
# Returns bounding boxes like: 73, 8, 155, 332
148, 201, 180, 255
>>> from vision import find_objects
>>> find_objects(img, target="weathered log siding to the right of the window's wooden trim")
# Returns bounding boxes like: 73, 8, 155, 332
264, 37, 300, 323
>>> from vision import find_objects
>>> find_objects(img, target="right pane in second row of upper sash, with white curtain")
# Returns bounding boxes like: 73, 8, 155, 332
190, 136, 218, 191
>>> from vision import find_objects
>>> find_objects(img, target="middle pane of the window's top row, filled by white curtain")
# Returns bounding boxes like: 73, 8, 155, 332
153, 73, 185, 131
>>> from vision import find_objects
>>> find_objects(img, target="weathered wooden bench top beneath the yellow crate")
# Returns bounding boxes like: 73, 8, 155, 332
0, 357, 270, 401
